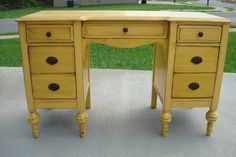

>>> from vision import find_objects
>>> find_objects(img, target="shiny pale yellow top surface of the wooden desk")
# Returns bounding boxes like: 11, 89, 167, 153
17, 10, 230, 22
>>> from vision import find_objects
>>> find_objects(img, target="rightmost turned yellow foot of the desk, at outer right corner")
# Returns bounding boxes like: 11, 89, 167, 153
206, 110, 218, 136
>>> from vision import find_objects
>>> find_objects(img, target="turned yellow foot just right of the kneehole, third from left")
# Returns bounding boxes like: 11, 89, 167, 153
161, 112, 171, 137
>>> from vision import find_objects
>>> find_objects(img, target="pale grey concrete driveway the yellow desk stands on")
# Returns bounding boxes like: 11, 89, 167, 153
0, 67, 236, 157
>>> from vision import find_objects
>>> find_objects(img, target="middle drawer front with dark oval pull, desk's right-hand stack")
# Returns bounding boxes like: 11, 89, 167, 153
174, 46, 219, 72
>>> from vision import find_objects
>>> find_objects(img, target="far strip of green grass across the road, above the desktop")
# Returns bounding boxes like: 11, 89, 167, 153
0, 4, 214, 19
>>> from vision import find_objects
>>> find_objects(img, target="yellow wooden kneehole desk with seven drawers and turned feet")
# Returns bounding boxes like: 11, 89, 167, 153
17, 11, 230, 138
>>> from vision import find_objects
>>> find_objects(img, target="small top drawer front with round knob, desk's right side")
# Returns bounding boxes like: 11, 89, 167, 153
177, 26, 221, 42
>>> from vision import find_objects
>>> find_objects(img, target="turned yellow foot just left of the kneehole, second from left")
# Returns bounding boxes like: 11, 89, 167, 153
76, 112, 88, 137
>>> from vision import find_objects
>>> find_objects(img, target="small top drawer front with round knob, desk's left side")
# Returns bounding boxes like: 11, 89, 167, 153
27, 25, 73, 42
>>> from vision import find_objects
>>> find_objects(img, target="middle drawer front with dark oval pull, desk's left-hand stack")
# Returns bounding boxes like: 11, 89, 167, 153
29, 47, 75, 73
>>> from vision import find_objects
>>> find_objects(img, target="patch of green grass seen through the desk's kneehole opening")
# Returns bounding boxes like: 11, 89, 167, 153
90, 44, 153, 70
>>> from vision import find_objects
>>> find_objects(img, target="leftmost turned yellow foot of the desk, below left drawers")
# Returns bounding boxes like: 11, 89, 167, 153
28, 111, 39, 138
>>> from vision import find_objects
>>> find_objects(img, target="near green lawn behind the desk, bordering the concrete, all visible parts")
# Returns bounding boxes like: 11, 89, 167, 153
0, 32, 236, 72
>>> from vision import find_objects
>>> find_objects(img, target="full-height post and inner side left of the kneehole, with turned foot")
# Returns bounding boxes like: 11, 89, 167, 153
73, 21, 89, 137
